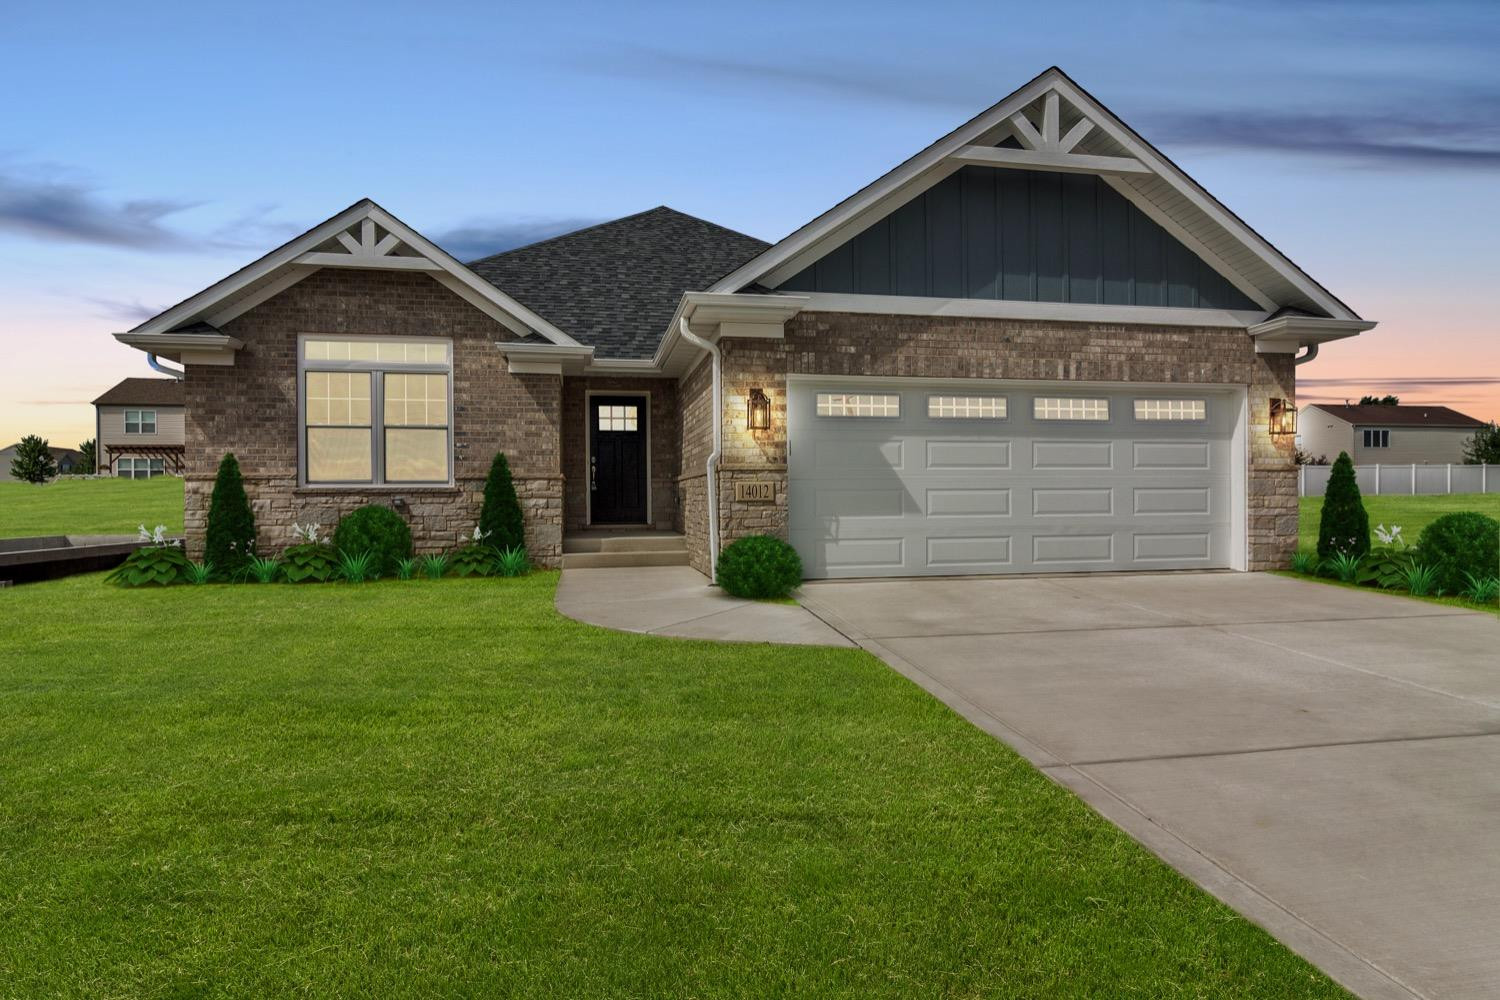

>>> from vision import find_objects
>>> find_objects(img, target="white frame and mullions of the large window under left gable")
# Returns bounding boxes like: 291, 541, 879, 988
297, 333, 458, 492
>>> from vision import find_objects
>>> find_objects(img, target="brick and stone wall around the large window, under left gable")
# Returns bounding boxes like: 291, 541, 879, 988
185, 268, 564, 565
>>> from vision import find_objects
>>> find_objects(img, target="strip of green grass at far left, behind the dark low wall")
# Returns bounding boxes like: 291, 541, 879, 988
0, 475, 183, 538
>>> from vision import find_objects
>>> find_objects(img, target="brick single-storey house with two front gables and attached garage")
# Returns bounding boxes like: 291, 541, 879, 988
116, 69, 1374, 577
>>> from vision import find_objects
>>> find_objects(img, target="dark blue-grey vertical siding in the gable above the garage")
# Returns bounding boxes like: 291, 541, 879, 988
782, 166, 1257, 309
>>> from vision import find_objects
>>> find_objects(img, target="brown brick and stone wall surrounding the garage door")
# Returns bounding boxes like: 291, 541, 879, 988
683, 312, 1298, 571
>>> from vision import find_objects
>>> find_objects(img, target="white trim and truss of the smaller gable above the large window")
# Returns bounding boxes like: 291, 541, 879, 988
131, 198, 579, 346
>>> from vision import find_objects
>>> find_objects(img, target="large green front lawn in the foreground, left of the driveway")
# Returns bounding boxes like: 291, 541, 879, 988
0, 573, 1346, 999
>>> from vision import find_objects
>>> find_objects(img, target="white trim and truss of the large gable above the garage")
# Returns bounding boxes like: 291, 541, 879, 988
710, 67, 1359, 319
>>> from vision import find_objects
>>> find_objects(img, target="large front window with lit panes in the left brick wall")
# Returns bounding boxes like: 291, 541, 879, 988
302, 337, 453, 486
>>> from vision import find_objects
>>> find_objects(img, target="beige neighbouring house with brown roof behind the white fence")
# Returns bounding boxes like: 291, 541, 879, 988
1299, 403, 1487, 465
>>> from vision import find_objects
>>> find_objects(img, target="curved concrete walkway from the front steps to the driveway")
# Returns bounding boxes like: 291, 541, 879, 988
557, 567, 854, 646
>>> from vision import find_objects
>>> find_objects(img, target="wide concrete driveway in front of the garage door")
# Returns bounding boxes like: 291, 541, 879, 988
804, 573, 1500, 999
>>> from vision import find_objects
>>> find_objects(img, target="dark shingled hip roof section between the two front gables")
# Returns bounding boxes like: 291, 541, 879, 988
468, 205, 770, 358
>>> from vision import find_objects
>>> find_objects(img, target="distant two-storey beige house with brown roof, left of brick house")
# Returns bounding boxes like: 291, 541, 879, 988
93, 378, 186, 480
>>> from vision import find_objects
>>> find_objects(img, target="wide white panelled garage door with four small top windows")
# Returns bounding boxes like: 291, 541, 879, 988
788, 378, 1241, 577
